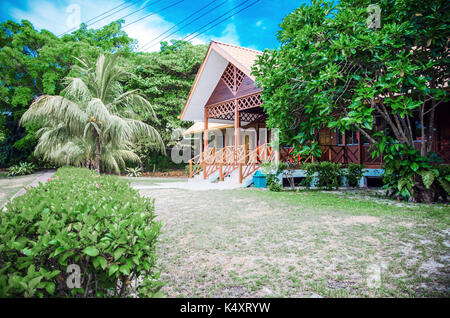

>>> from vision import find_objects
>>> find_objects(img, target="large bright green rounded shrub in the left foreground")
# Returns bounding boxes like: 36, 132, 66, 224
0, 167, 161, 297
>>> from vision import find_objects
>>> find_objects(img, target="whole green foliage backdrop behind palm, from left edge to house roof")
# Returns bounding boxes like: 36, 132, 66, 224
0, 20, 206, 170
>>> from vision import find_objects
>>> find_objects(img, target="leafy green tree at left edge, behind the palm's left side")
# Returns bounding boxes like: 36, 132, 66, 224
0, 20, 135, 166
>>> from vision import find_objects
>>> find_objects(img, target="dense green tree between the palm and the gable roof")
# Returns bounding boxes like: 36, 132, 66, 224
122, 41, 207, 169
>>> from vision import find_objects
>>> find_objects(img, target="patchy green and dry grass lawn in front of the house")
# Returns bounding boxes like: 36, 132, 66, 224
140, 189, 450, 297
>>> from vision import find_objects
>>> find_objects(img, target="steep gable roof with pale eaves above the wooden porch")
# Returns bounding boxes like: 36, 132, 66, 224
178, 41, 262, 121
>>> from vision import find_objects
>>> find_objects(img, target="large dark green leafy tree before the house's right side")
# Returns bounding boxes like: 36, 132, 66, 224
254, 0, 450, 202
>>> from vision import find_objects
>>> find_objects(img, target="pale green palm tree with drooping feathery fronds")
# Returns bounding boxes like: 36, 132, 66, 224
20, 54, 164, 173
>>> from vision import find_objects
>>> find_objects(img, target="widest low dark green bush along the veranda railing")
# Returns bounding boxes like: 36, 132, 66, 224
302, 161, 344, 190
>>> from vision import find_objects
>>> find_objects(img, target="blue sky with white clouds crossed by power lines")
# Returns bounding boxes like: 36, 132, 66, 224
0, 0, 309, 51
